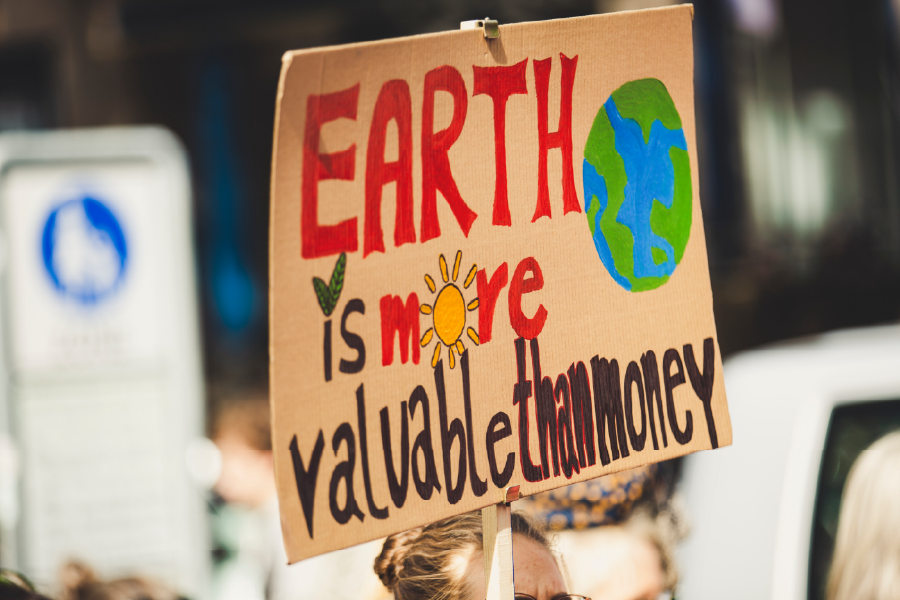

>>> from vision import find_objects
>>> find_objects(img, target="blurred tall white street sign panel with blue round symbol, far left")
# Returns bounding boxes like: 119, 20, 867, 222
0, 128, 209, 597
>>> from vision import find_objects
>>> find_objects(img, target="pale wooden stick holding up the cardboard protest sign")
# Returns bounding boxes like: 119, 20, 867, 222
481, 502, 515, 600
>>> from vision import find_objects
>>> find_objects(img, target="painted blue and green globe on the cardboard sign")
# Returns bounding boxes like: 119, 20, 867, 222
583, 79, 693, 292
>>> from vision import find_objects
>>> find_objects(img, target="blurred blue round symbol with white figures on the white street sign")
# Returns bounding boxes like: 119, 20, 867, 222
41, 196, 128, 305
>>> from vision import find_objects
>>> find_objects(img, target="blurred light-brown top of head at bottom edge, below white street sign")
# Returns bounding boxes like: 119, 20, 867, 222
59, 561, 184, 600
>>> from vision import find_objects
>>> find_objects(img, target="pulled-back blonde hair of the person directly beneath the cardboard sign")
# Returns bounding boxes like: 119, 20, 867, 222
375, 511, 551, 600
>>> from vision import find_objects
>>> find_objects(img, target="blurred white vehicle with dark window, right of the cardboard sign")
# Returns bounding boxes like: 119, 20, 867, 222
678, 326, 900, 600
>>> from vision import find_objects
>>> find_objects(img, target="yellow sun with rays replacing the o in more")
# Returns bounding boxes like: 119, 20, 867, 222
421, 250, 478, 369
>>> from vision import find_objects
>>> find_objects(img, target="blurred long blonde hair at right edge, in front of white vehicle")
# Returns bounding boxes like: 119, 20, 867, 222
826, 431, 900, 600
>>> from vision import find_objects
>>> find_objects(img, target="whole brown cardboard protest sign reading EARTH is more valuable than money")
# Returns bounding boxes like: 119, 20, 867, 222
270, 6, 731, 561
